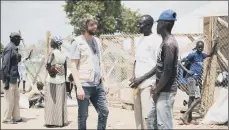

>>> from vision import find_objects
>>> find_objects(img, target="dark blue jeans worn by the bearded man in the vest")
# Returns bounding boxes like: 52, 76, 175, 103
77, 84, 109, 130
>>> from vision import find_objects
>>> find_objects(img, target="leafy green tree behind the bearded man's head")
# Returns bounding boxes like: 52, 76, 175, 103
64, 0, 141, 35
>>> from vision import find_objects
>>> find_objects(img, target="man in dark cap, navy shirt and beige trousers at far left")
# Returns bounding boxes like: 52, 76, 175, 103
2, 32, 22, 124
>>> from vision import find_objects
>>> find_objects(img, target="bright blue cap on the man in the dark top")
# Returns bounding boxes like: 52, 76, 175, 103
158, 9, 177, 21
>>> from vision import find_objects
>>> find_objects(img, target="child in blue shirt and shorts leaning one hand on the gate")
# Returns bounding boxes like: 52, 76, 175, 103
179, 40, 218, 124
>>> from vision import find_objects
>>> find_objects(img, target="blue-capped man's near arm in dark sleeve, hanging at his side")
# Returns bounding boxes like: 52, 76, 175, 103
154, 45, 176, 94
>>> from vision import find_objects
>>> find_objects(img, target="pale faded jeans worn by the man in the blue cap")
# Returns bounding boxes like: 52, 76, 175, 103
147, 92, 176, 129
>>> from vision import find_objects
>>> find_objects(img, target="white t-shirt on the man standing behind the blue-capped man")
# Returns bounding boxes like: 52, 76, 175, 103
135, 34, 161, 89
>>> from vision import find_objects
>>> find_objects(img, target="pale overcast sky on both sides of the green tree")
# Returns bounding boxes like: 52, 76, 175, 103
1, 1, 222, 45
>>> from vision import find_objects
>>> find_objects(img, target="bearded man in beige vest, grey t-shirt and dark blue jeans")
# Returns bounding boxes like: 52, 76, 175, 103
70, 14, 109, 129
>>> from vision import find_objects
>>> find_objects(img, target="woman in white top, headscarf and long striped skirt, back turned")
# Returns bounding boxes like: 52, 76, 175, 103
45, 37, 68, 128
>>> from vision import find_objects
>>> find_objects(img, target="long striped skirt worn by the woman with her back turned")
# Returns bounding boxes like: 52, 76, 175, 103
45, 83, 68, 126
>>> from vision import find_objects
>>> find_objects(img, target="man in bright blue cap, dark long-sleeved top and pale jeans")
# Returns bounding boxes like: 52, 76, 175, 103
128, 10, 179, 129
